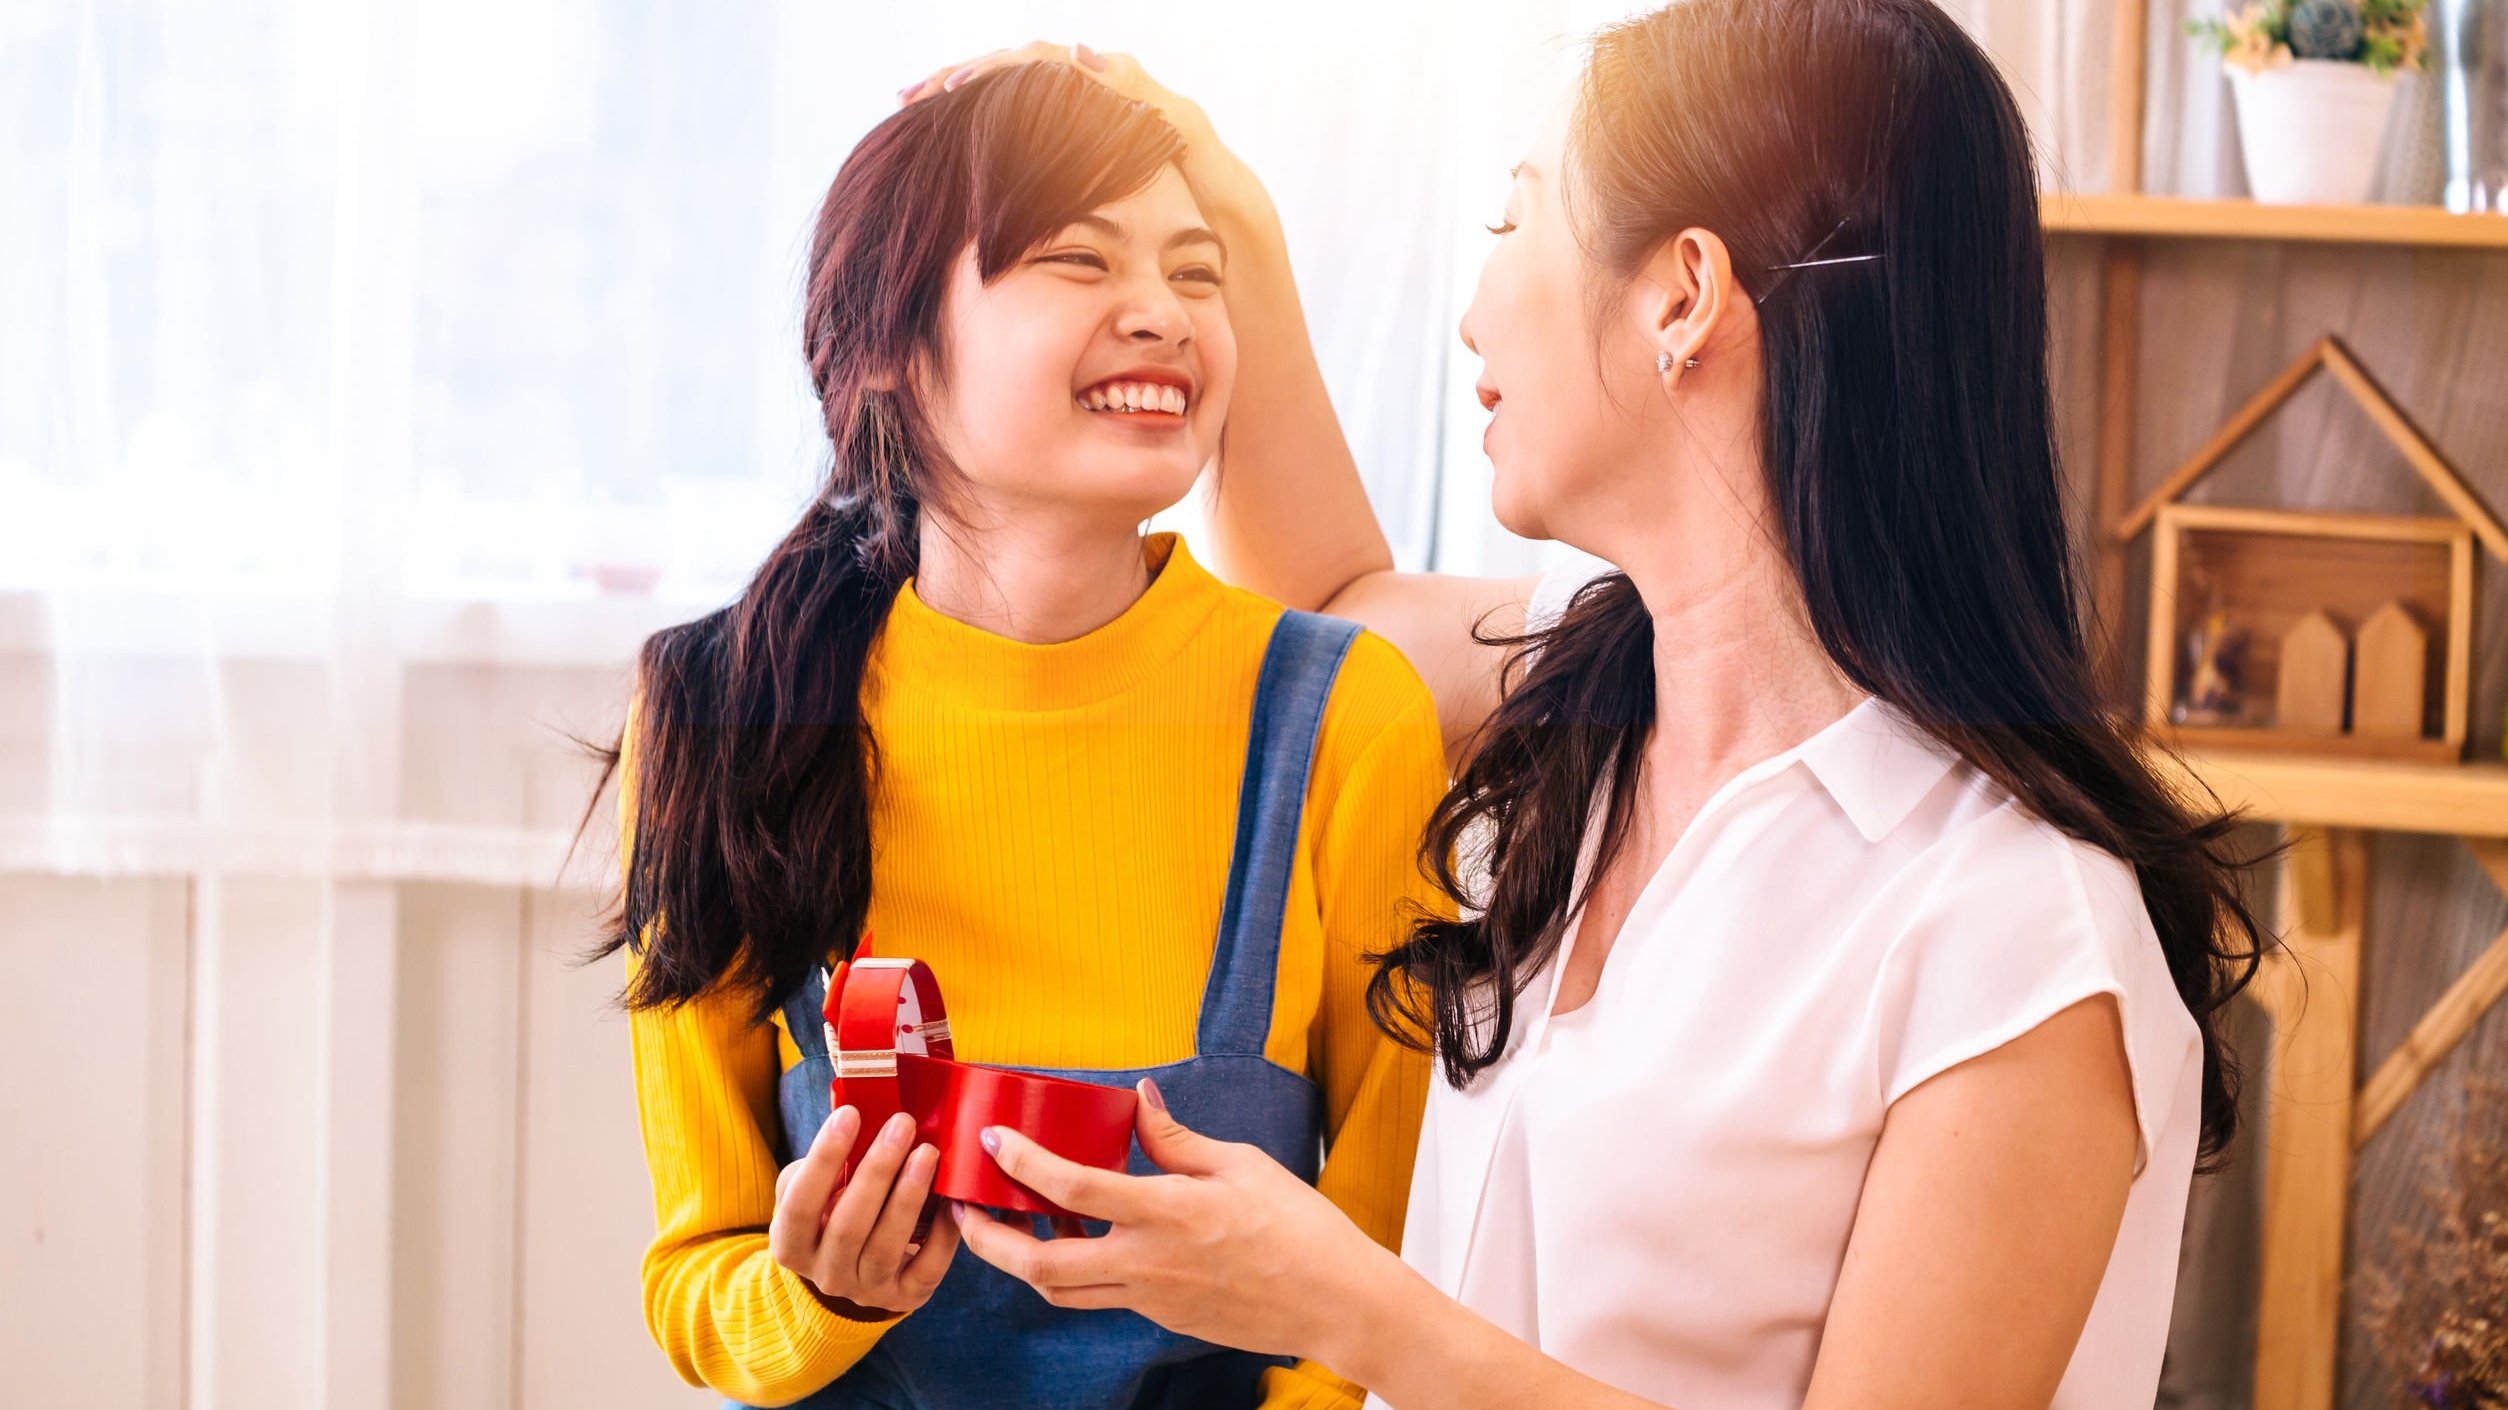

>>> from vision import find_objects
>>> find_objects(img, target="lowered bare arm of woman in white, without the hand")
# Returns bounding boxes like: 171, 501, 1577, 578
1322, 996, 2134, 1410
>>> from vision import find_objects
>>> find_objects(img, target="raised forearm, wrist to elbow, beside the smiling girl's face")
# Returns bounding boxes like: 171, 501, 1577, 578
1206, 168, 1394, 610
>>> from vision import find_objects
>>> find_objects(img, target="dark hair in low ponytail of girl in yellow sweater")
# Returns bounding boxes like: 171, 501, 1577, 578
597, 63, 1181, 1019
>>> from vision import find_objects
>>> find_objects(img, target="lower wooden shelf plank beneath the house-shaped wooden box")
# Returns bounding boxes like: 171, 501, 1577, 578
2152, 748, 2508, 838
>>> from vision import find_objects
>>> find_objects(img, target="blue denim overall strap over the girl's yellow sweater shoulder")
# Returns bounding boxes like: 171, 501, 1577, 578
1196, 612, 1359, 1056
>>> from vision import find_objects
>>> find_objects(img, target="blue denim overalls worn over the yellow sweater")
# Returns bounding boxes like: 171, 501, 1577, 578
752, 612, 1357, 1410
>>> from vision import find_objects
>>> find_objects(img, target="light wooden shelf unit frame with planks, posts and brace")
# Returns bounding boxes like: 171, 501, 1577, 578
2076, 0, 2508, 1410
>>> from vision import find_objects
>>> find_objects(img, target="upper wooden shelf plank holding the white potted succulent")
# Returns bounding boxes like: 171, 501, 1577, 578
2039, 191, 2508, 248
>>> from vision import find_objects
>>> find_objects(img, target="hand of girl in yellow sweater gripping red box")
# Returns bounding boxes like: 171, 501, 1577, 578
767, 1106, 958, 1320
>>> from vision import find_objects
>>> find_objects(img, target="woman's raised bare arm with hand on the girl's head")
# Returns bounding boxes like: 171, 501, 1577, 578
905, 43, 1535, 758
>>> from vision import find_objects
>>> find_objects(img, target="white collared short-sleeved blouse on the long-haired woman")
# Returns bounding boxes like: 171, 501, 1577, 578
1369, 559, 2202, 1410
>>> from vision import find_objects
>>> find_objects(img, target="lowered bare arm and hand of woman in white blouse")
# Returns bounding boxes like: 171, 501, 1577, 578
963, 996, 2134, 1410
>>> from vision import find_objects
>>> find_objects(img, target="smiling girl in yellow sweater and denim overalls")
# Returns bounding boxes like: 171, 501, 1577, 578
586, 65, 1445, 1407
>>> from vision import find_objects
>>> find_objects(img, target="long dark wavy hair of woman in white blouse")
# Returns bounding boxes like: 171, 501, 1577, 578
1369, 0, 2270, 1159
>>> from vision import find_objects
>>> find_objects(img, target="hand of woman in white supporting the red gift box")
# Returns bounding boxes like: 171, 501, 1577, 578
958, 1081, 1404, 1365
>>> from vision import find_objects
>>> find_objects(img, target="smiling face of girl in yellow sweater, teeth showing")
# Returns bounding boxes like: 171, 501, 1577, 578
925, 166, 1236, 524
